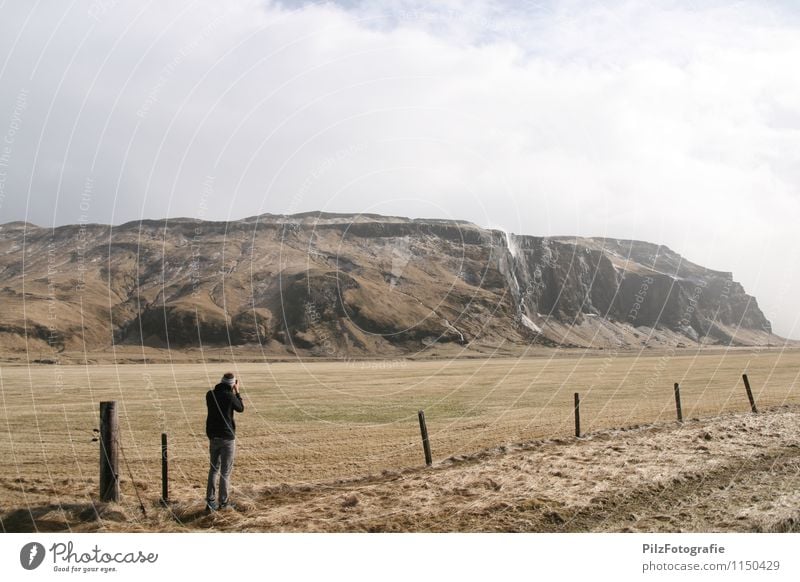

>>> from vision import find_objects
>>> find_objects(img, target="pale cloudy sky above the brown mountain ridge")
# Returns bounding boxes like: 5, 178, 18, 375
0, 0, 800, 338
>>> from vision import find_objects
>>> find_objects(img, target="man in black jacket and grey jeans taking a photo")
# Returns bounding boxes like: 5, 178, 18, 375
206, 372, 244, 511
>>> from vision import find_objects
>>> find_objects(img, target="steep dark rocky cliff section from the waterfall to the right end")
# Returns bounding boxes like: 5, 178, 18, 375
506, 235, 772, 345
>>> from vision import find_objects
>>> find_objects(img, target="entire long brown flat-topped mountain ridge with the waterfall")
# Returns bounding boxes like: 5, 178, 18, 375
0, 213, 780, 357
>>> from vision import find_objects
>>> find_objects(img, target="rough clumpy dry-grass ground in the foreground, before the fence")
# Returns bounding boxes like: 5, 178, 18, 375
2, 405, 800, 532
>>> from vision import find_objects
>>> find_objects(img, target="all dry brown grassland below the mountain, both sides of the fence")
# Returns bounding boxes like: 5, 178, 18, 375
0, 349, 800, 531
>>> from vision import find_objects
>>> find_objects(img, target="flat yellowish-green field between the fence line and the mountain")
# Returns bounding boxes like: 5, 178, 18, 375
0, 350, 800, 524
